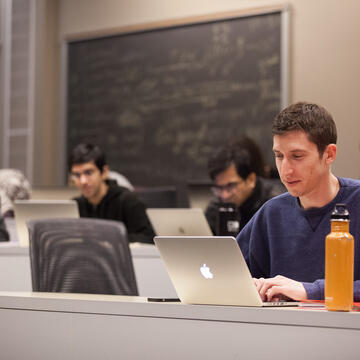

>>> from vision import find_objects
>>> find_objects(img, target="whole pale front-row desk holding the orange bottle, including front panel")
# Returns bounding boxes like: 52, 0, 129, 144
0, 292, 360, 360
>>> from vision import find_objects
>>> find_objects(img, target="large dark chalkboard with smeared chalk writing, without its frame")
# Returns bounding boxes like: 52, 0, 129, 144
66, 11, 288, 185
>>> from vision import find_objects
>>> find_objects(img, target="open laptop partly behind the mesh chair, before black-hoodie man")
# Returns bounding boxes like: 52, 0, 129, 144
14, 200, 79, 246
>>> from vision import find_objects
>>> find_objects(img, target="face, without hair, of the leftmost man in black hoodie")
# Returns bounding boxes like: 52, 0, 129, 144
71, 161, 107, 201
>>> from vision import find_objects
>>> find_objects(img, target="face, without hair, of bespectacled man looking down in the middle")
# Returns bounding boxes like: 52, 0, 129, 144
213, 164, 256, 206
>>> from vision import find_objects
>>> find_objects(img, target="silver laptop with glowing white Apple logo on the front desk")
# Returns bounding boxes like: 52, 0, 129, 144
154, 236, 298, 306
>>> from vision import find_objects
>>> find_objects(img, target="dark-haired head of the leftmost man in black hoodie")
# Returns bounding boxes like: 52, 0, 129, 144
68, 144, 108, 203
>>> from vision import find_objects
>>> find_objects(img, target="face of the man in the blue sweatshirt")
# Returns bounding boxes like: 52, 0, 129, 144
273, 131, 329, 200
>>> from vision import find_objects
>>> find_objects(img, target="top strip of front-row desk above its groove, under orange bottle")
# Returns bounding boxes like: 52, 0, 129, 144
0, 291, 360, 335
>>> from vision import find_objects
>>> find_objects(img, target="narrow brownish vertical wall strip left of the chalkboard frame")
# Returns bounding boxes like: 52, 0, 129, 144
33, 0, 63, 186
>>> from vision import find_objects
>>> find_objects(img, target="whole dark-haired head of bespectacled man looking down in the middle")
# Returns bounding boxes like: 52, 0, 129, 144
208, 143, 256, 206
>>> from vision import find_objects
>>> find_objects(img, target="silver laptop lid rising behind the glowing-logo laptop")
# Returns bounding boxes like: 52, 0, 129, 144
146, 208, 213, 236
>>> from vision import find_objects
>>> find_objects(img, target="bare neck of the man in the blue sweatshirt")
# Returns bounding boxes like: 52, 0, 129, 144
299, 173, 340, 210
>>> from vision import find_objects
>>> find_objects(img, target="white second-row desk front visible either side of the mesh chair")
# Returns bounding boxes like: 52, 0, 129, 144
0, 243, 176, 297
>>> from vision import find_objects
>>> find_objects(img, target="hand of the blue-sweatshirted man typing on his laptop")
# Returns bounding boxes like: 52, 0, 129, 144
254, 275, 307, 301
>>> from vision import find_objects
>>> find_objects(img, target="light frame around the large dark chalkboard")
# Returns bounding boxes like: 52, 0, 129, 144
59, 4, 290, 184
